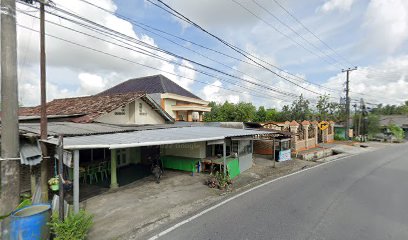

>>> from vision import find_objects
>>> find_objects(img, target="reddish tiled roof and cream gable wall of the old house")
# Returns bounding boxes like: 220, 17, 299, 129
19, 92, 174, 125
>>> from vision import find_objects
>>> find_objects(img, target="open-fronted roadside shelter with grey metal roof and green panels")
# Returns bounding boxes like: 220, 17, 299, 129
45, 126, 270, 212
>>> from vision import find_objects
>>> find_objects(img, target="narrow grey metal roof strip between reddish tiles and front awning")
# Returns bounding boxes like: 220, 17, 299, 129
19, 122, 177, 136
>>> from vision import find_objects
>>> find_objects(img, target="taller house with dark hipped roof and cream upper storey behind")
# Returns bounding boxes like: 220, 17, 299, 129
97, 75, 211, 122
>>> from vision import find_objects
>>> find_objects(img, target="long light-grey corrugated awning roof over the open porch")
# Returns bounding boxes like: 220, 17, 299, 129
47, 127, 270, 149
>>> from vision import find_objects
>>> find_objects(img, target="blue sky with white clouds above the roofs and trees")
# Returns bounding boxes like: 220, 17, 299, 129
2, 0, 408, 109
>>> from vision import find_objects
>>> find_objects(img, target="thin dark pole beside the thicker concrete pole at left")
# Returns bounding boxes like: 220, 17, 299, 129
40, 0, 49, 202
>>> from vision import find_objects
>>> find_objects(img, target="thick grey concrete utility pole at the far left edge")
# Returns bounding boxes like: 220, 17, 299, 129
0, 0, 20, 234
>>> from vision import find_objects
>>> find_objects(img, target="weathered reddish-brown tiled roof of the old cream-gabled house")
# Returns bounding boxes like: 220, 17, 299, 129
19, 92, 146, 123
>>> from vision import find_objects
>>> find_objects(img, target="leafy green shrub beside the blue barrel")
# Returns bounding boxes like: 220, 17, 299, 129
48, 210, 93, 240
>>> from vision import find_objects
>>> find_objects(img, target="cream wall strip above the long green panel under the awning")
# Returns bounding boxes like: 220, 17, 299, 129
160, 142, 206, 158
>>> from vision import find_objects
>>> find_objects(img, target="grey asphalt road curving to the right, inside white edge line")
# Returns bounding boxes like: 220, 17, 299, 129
152, 144, 408, 240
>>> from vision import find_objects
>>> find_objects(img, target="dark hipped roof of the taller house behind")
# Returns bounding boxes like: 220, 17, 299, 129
97, 74, 200, 99
